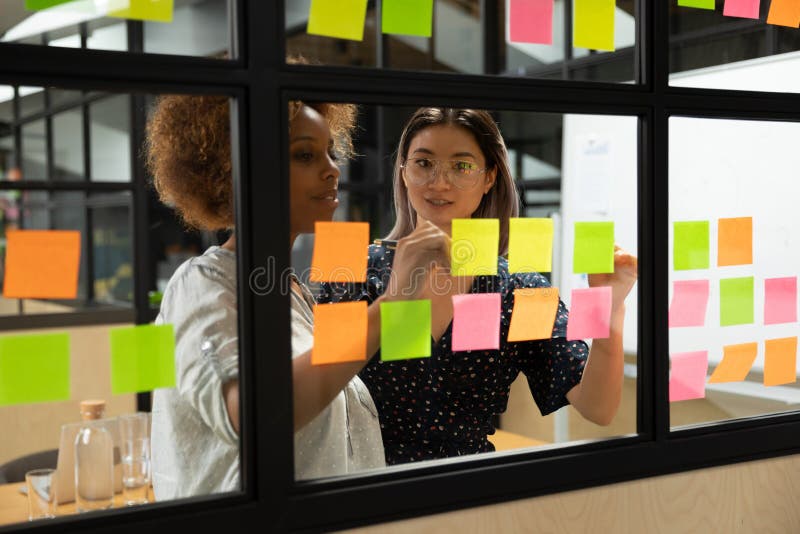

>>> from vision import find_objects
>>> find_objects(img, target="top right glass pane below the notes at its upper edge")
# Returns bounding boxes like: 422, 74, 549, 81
670, 2, 800, 92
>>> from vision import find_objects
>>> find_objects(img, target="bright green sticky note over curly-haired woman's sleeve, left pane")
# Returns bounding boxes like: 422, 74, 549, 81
111, 324, 175, 395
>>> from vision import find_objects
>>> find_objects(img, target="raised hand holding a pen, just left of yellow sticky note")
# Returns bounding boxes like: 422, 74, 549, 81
384, 220, 450, 301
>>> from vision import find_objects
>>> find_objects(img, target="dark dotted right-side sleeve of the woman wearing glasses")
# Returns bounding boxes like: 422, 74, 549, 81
508, 273, 589, 415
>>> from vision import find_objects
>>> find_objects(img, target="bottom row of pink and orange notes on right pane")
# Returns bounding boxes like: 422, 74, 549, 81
669, 337, 797, 402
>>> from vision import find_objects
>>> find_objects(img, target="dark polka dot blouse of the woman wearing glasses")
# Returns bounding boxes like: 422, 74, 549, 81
318, 245, 589, 465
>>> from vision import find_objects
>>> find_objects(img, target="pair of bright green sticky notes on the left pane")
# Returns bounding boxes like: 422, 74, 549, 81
0, 325, 175, 406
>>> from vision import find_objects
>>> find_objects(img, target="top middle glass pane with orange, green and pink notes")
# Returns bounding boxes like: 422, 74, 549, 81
285, 0, 637, 83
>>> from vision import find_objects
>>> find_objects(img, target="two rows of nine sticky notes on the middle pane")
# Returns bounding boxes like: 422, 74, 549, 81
310, 218, 614, 365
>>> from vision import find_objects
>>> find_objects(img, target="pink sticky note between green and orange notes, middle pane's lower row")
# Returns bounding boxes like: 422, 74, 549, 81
453, 293, 500, 351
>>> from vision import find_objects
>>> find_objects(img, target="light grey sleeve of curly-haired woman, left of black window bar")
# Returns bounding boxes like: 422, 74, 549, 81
158, 263, 239, 444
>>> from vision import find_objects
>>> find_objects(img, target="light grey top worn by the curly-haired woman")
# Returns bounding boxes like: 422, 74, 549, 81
152, 246, 384, 500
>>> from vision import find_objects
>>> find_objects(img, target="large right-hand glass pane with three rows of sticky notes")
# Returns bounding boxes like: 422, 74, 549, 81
669, 117, 800, 429
